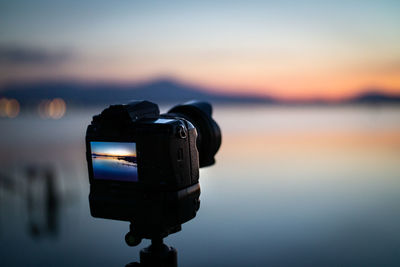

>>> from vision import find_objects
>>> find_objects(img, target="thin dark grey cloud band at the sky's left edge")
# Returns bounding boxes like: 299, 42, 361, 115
0, 45, 73, 65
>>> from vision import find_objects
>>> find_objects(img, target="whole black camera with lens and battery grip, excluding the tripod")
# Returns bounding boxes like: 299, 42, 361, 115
86, 101, 221, 245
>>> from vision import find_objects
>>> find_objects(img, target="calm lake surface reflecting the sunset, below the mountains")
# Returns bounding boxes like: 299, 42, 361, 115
0, 106, 400, 266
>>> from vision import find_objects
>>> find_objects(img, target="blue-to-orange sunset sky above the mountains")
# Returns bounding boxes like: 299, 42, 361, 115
0, 0, 400, 99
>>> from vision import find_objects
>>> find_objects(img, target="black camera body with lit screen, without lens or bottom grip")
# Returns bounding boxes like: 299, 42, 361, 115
86, 101, 199, 190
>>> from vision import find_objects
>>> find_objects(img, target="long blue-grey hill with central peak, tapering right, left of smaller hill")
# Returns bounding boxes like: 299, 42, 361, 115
0, 79, 275, 106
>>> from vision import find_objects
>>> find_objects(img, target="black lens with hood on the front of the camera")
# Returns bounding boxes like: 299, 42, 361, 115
168, 101, 221, 167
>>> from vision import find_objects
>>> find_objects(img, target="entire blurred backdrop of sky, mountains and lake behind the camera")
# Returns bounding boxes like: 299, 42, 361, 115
0, 0, 400, 266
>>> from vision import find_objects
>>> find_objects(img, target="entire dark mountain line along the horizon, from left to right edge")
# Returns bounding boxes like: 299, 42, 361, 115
0, 78, 400, 107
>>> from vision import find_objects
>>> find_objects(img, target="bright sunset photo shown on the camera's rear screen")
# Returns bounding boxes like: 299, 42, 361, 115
90, 142, 138, 182
